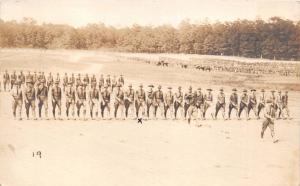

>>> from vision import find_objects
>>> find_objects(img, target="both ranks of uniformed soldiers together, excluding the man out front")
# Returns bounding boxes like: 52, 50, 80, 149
3, 71, 290, 126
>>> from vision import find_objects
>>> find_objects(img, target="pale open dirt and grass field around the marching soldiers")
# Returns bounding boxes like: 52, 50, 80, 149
0, 49, 300, 186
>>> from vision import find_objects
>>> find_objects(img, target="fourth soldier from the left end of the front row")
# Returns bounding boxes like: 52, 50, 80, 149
51, 79, 62, 119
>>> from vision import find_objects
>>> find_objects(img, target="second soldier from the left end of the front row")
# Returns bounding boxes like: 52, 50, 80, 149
23, 80, 36, 120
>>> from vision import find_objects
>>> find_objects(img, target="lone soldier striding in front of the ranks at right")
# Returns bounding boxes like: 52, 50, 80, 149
260, 100, 278, 143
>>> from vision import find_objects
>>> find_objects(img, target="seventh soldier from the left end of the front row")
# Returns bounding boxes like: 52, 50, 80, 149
89, 82, 100, 119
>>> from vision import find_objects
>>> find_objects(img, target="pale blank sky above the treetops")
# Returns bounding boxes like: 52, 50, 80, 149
0, 0, 300, 26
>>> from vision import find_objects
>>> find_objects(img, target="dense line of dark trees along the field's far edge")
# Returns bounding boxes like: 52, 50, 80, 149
0, 17, 300, 60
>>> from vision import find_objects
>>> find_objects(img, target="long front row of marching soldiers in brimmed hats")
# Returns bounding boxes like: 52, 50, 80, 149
5, 70, 289, 122
